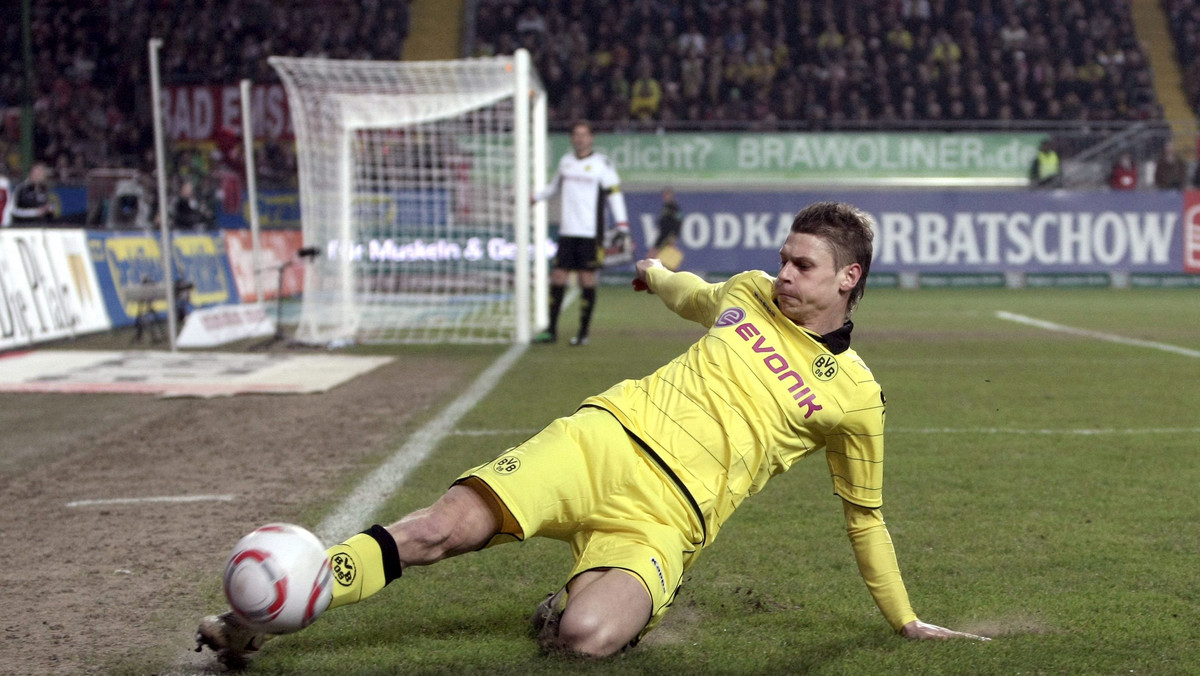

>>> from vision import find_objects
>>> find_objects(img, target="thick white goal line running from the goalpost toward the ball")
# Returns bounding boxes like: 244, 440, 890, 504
316, 343, 528, 543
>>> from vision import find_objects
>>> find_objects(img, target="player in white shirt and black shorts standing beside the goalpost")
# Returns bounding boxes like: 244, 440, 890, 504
533, 121, 630, 345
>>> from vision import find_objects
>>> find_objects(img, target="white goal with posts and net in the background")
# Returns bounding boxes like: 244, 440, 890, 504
270, 50, 547, 345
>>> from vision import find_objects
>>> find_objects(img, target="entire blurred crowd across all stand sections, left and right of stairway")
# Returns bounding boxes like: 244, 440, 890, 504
0, 0, 1200, 210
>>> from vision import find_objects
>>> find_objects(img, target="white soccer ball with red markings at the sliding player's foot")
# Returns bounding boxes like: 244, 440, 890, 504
224, 524, 334, 634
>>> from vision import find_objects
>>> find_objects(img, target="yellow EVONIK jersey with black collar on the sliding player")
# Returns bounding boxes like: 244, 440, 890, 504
582, 269, 884, 544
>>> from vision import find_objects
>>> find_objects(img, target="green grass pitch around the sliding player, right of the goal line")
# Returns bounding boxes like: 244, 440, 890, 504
189, 287, 1200, 676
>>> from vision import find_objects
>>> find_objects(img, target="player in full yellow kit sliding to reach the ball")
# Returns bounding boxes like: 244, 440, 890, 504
198, 202, 982, 657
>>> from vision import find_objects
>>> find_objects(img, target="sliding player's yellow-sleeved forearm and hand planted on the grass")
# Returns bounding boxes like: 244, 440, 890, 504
841, 499, 989, 640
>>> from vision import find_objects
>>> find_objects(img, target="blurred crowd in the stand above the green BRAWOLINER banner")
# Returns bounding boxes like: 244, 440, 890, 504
474, 0, 1162, 130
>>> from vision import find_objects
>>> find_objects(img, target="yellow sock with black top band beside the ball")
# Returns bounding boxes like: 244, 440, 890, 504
325, 526, 401, 608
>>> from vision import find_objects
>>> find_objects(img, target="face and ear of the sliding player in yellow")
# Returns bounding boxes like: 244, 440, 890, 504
775, 233, 862, 334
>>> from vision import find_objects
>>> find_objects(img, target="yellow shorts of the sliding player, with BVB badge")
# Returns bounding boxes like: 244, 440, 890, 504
458, 408, 703, 636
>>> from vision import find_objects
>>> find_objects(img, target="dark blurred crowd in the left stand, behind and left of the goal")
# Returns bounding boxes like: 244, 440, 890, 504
0, 0, 409, 206
